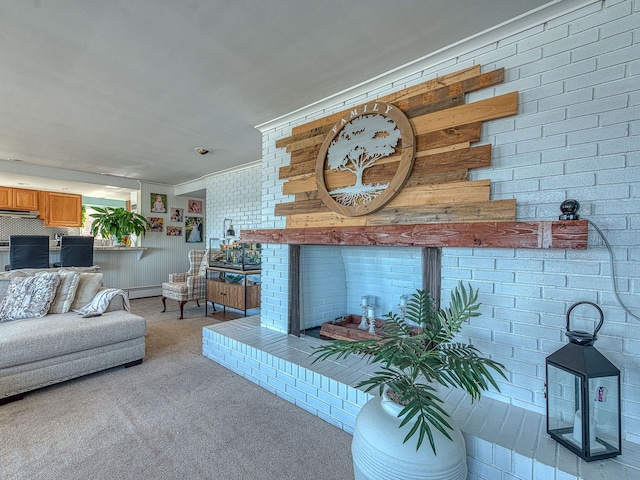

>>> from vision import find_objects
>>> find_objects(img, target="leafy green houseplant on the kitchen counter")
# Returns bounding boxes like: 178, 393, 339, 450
91, 207, 149, 246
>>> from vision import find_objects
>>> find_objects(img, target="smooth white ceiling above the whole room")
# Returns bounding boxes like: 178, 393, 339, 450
0, 0, 548, 196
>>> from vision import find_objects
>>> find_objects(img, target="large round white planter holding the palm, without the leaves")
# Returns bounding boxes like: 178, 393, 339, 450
351, 393, 467, 480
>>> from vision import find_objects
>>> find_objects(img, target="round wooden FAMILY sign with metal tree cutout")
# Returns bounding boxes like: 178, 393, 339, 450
316, 102, 415, 216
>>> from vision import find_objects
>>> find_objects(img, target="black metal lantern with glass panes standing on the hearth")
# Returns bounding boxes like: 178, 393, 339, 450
546, 302, 622, 462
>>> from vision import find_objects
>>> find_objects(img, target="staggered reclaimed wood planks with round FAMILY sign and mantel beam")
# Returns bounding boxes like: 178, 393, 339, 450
246, 65, 588, 249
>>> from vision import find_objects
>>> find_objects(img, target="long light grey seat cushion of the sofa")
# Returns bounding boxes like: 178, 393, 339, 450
0, 310, 147, 369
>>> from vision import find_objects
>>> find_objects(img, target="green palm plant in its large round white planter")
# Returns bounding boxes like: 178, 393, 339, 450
313, 282, 506, 480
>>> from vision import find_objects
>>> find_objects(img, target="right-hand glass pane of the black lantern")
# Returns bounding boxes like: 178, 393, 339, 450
588, 376, 620, 455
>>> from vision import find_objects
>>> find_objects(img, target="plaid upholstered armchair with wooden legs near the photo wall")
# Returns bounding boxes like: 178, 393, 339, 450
162, 250, 209, 318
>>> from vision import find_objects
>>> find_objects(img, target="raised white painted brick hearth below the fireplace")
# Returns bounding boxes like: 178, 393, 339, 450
202, 316, 640, 480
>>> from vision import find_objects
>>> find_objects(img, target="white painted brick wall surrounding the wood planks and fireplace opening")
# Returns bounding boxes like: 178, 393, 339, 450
254, 0, 640, 454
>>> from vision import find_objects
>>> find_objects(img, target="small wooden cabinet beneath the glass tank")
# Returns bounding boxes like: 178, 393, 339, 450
204, 267, 260, 317
